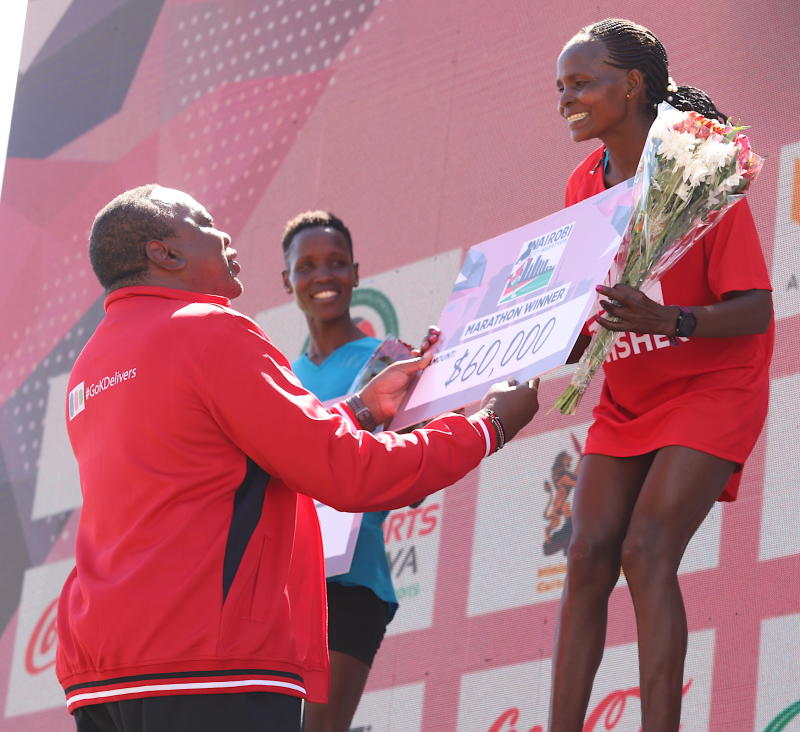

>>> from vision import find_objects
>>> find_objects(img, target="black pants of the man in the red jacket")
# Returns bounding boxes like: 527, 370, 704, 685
75, 692, 300, 732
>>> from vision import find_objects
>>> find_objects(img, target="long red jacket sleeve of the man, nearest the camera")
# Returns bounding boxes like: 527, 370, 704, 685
197, 313, 492, 511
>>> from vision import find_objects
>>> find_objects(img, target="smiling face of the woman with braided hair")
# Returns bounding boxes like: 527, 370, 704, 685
556, 40, 630, 142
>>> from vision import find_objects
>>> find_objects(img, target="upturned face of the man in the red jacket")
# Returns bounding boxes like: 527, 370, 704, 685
150, 187, 244, 299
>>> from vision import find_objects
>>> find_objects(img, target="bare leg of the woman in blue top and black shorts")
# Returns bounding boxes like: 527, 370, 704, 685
303, 651, 369, 732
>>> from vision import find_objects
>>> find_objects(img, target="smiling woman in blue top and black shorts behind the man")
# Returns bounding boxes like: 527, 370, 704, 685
283, 211, 436, 732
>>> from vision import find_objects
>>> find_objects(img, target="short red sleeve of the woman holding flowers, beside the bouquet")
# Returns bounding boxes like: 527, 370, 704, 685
703, 198, 772, 299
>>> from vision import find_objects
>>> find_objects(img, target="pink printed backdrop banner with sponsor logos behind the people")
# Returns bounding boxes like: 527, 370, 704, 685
0, 0, 800, 732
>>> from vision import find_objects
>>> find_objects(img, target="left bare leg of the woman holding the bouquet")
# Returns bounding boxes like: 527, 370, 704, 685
550, 455, 653, 732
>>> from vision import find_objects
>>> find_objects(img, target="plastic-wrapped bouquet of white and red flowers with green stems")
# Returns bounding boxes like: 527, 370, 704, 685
555, 102, 763, 414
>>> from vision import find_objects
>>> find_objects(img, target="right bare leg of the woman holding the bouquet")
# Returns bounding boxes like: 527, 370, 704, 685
622, 446, 735, 732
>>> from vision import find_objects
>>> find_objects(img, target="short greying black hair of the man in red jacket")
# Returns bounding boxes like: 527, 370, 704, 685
89, 183, 175, 291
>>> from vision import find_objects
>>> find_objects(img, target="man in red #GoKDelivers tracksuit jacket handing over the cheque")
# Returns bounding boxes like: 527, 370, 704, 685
57, 186, 537, 732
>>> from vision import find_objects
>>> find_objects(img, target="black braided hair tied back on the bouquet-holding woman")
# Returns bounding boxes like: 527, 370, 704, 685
567, 18, 727, 122
